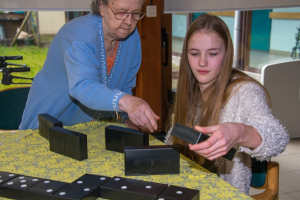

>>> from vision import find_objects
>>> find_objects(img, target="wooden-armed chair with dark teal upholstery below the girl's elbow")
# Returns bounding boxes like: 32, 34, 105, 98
251, 158, 279, 200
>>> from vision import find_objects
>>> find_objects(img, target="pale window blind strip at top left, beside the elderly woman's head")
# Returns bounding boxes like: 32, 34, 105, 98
0, 0, 92, 11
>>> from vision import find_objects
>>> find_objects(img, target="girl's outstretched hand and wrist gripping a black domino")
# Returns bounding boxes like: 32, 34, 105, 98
189, 123, 262, 160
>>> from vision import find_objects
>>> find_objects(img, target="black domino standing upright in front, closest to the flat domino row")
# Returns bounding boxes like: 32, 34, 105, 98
124, 145, 180, 176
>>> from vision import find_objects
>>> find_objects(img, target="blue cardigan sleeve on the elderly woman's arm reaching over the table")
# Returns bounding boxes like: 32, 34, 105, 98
64, 41, 135, 111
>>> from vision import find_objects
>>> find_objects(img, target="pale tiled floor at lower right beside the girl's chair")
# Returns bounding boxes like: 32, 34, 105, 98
250, 138, 300, 200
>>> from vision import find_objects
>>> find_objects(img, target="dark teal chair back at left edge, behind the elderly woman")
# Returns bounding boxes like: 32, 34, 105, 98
0, 87, 30, 130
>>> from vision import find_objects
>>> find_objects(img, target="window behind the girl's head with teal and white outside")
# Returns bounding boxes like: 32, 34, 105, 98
172, 7, 300, 88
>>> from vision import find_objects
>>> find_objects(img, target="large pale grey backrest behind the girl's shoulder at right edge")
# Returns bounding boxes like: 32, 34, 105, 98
262, 60, 300, 138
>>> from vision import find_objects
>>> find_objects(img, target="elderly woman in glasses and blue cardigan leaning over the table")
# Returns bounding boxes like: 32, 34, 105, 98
19, 0, 159, 132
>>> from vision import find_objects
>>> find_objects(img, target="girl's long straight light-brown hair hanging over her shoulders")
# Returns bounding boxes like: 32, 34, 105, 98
169, 14, 267, 161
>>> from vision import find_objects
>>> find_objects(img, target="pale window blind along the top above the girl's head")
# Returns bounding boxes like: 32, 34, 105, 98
164, 0, 300, 13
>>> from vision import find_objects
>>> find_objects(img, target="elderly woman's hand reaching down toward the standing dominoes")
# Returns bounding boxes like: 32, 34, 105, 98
119, 95, 159, 132
